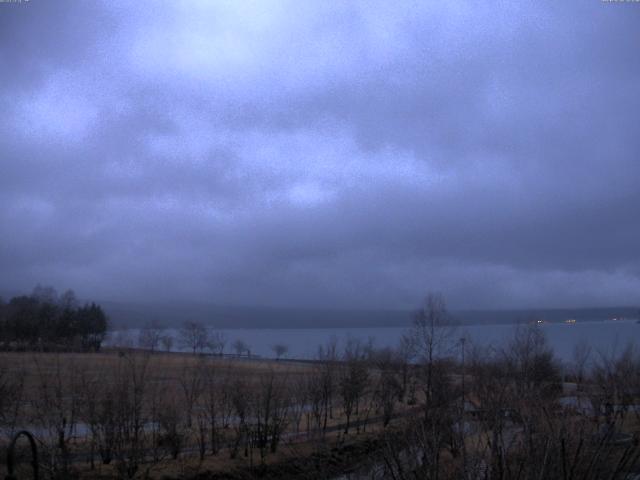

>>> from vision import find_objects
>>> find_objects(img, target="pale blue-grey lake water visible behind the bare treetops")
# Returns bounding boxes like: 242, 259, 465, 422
109, 320, 640, 360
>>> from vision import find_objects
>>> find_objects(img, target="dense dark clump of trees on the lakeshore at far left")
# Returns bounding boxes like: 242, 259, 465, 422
0, 286, 108, 351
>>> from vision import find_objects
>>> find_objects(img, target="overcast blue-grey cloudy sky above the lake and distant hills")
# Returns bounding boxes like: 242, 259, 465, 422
0, 0, 640, 308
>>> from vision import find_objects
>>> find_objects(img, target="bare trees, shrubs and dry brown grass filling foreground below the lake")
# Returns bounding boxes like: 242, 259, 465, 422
0, 296, 640, 480
